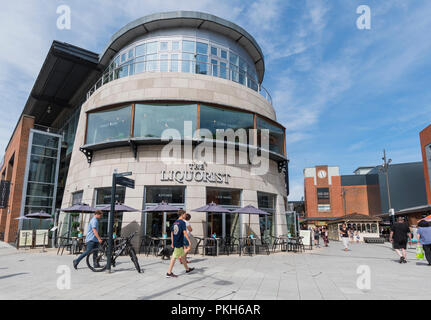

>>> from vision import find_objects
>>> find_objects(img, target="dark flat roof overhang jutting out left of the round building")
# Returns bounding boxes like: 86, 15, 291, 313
22, 41, 100, 127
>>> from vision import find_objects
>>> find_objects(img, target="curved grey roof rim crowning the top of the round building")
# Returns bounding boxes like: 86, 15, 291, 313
100, 11, 265, 83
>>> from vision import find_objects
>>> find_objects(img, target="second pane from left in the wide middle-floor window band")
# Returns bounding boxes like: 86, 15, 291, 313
134, 104, 197, 138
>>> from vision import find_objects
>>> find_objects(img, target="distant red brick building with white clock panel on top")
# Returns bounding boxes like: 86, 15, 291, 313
304, 166, 381, 224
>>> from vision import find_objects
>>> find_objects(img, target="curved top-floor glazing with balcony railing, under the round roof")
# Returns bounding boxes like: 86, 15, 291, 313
88, 36, 271, 102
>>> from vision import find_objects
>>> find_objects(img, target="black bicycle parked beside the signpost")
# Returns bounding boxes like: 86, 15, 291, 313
87, 232, 141, 273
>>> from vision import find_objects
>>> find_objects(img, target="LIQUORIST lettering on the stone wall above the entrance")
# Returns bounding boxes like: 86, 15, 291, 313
160, 163, 230, 184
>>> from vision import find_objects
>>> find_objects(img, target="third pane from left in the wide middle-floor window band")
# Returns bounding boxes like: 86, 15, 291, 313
200, 104, 254, 143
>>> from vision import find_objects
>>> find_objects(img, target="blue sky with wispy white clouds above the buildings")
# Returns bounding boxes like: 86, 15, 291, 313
0, 0, 431, 200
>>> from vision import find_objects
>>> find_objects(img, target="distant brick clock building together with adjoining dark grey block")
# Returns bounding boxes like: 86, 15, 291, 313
304, 162, 431, 225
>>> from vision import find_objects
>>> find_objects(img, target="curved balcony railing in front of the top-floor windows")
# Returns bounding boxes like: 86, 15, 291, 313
87, 59, 272, 104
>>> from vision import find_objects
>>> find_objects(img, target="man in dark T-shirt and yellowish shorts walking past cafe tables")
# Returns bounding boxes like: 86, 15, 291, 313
166, 210, 194, 278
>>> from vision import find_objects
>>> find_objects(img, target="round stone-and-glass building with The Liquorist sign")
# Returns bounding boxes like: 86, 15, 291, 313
0, 11, 288, 248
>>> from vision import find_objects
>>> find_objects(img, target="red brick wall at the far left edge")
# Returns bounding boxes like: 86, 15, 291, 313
0, 115, 34, 242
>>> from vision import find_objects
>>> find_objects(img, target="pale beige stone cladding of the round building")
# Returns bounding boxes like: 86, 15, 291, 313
62, 73, 287, 248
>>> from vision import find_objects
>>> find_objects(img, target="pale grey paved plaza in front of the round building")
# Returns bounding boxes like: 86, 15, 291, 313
0, 242, 431, 300
